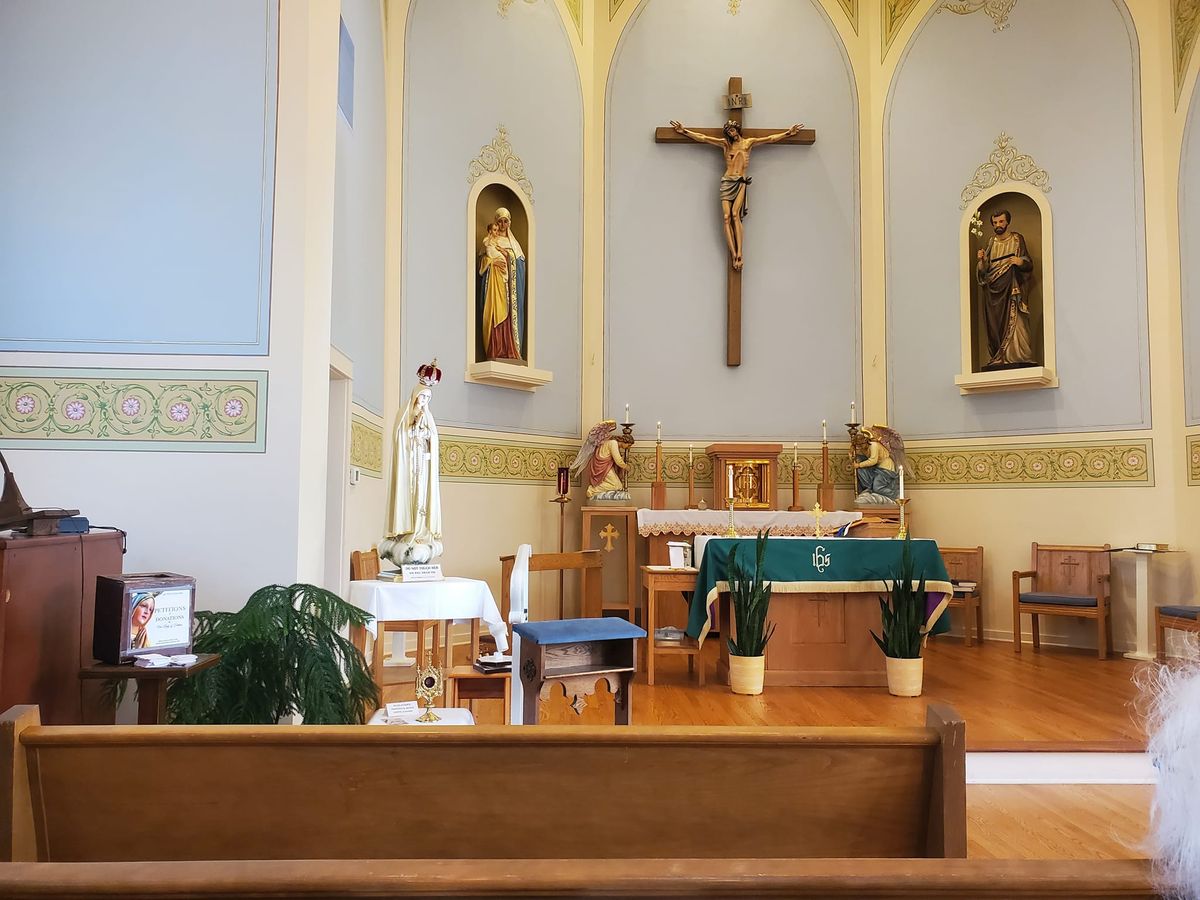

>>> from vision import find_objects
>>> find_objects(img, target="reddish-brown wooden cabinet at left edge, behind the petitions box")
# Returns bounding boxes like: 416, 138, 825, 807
0, 532, 121, 725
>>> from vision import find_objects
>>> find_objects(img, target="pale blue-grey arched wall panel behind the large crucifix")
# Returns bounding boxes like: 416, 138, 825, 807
605, 0, 859, 439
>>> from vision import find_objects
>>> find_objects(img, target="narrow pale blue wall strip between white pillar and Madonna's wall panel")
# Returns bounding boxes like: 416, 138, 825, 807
330, 0, 386, 415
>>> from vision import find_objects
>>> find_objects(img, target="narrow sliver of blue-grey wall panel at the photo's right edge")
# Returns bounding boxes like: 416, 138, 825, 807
1180, 66, 1200, 426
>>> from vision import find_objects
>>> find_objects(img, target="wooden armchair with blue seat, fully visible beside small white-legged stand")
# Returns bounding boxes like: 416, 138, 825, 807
1013, 544, 1112, 659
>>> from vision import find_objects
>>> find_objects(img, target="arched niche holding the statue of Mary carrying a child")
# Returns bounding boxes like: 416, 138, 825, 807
466, 174, 553, 391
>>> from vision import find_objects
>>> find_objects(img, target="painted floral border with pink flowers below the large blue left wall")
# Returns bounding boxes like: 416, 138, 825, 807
0, 368, 266, 452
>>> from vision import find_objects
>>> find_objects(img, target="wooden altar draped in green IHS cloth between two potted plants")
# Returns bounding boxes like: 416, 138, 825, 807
688, 536, 953, 686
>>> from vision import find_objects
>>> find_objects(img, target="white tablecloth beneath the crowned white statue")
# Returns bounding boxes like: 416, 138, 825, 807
350, 577, 509, 653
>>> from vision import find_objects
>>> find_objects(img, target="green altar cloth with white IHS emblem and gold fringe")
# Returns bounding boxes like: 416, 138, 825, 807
688, 538, 954, 642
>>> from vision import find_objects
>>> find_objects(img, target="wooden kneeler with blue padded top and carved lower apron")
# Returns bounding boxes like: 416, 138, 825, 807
512, 616, 646, 725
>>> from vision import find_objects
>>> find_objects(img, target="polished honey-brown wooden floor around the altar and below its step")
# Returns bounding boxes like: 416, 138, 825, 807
386, 637, 1153, 859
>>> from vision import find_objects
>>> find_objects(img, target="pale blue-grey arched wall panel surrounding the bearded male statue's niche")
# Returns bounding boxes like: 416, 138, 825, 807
884, 0, 1151, 438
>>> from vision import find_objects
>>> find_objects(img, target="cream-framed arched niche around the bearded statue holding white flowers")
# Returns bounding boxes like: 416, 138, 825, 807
954, 182, 1058, 394
